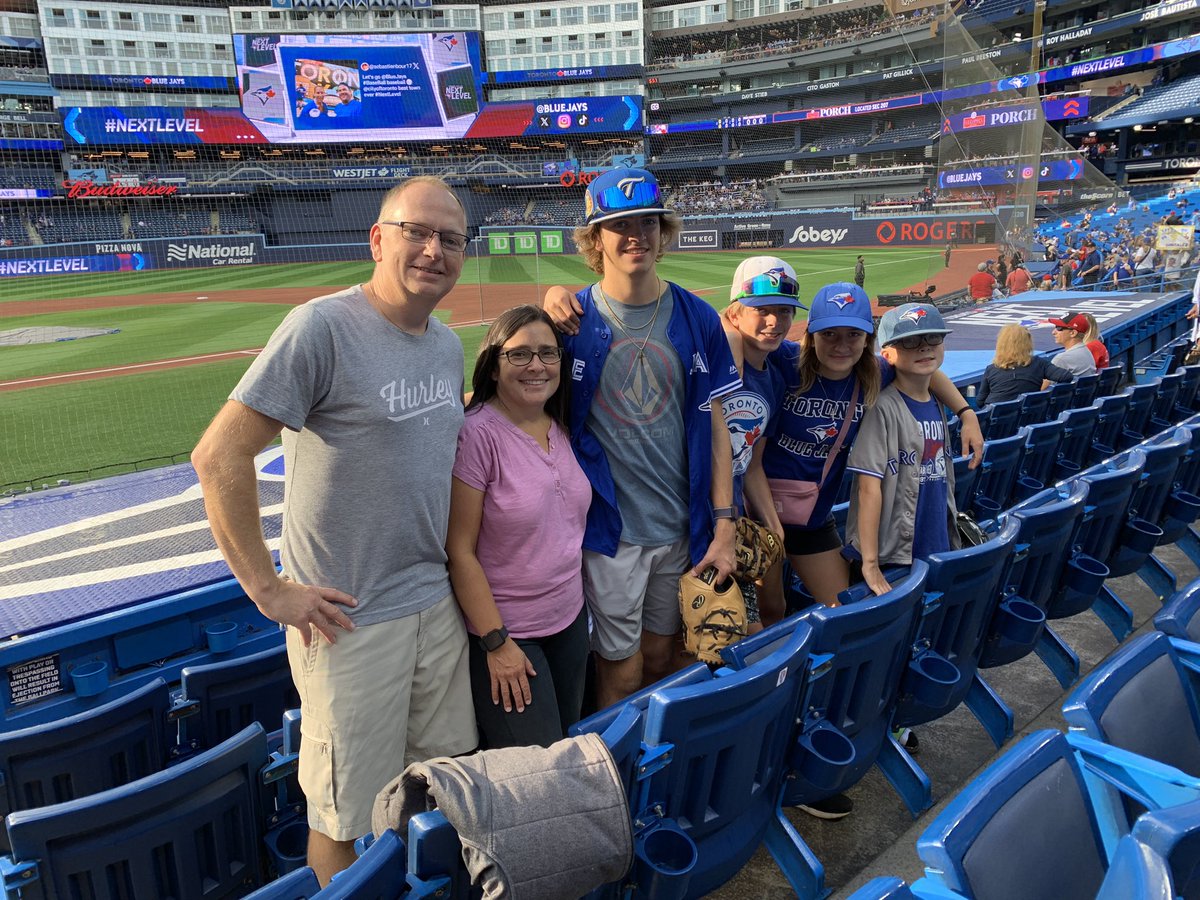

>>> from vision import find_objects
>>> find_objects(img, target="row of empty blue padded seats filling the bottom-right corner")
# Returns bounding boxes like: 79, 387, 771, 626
852, 580, 1200, 900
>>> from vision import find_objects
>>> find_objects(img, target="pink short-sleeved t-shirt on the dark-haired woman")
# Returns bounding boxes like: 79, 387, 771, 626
454, 403, 592, 637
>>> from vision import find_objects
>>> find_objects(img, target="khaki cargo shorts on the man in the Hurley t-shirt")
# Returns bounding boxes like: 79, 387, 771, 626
288, 595, 479, 841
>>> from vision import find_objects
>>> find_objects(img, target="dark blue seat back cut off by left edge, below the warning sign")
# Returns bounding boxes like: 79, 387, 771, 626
0, 678, 175, 852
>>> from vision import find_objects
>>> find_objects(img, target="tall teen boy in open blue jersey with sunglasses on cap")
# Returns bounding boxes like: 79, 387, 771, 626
561, 169, 742, 707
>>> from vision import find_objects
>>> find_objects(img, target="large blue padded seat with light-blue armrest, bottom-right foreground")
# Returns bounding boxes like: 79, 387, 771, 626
917, 731, 1200, 900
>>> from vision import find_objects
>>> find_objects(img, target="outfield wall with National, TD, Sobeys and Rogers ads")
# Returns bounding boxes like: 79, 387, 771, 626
0, 212, 996, 278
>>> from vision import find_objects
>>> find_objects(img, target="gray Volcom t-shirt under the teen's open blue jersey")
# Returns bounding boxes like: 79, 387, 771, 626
588, 286, 688, 547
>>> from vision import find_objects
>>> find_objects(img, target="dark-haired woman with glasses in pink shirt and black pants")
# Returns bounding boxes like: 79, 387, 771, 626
446, 306, 592, 748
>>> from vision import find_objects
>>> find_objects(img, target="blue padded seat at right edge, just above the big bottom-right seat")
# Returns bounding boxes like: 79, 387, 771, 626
1062, 631, 1200, 778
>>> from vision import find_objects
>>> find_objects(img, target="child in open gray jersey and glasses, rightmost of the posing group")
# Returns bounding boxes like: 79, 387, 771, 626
846, 304, 960, 594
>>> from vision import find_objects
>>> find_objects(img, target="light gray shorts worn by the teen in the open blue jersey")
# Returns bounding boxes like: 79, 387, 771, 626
583, 538, 691, 660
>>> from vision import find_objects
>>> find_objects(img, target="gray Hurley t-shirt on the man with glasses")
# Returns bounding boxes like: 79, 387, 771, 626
230, 286, 463, 625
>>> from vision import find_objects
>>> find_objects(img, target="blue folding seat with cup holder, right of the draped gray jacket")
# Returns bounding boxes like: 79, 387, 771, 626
630, 623, 823, 896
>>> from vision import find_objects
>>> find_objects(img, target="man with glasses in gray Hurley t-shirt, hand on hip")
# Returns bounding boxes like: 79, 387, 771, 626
192, 178, 478, 883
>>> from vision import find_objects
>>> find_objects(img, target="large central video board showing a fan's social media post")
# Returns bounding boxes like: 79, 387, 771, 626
234, 31, 484, 144
